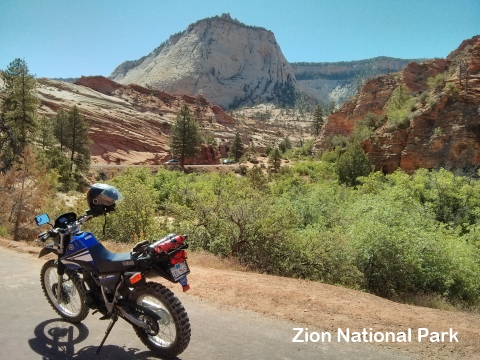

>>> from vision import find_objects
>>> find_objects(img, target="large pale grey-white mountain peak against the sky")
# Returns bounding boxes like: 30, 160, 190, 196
110, 14, 297, 108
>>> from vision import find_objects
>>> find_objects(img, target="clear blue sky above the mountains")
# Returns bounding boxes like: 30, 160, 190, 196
0, 0, 480, 77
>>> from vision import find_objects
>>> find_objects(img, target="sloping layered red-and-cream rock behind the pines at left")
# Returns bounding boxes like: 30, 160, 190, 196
37, 76, 235, 164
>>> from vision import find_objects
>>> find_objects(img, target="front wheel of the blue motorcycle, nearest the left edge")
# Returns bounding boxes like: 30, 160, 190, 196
40, 260, 88, 323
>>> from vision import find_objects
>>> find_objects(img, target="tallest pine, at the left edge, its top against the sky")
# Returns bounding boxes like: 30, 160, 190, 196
0, 58, 38, 172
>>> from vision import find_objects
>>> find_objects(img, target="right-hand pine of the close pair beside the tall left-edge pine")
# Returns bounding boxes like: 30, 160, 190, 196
65, 106, 90, 176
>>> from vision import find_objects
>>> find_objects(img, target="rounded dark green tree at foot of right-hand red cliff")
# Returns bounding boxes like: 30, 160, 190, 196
337, 142, 372, 186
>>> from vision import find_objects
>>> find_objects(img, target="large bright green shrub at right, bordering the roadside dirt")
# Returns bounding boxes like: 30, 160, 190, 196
344, 188, 480, 302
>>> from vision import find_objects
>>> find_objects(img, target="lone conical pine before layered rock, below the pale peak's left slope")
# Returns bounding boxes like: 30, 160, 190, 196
170, 105, 202, 166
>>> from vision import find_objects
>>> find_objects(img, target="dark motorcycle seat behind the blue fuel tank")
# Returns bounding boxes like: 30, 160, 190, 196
90, 243, 137, 273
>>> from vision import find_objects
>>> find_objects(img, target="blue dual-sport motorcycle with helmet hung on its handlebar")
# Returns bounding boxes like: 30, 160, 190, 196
35, 184, 190, 358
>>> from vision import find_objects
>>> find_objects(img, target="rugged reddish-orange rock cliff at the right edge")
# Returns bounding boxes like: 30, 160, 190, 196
317, 36, 480, 172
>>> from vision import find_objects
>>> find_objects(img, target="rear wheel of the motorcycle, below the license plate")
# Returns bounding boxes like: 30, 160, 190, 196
129, 283, 190, 358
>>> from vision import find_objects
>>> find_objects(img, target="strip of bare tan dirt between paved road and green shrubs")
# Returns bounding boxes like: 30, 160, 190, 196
0, 239, 480, 359
